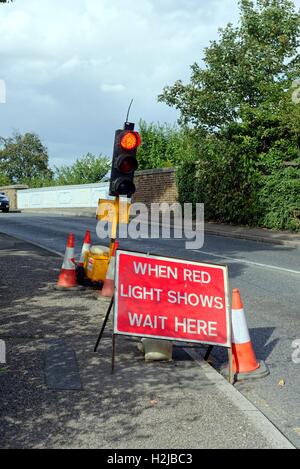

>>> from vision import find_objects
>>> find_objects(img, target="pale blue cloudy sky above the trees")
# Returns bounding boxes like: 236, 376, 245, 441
0, 0, 300, 167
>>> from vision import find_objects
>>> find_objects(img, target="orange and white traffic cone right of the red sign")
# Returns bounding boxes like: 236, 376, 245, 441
222, 289, 269, 380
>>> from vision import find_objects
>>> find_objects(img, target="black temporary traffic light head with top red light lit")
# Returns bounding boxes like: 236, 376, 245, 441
109, 122, 141, 197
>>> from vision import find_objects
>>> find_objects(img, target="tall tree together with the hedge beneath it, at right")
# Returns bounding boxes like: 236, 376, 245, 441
159, 0, 300, 229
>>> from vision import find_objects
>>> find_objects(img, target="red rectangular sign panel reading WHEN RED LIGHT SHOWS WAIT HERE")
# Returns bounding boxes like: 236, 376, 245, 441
114, 250, 231, 348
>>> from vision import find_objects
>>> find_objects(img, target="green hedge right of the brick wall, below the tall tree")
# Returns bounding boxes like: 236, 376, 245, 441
177, 134, 300, 230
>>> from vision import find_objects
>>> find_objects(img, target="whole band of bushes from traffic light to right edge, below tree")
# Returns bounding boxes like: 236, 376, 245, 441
139, 117, 300, 230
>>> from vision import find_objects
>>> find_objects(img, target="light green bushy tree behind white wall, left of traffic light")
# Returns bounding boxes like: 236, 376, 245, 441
54, 153, 111, 185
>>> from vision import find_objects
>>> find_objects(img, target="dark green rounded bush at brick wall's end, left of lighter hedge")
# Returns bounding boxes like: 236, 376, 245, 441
177, 133, 259, 224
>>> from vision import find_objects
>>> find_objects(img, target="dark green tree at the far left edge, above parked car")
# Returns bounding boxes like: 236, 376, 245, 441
0, 132, 52, 183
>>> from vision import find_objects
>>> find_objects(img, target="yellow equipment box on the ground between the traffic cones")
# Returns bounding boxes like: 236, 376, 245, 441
84, 246, 109, 282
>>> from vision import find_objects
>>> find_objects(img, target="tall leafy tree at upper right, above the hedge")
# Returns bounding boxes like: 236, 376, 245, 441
159, 0, 300, 132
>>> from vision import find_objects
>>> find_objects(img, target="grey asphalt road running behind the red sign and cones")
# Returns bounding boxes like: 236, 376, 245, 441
0, 214, 300, 448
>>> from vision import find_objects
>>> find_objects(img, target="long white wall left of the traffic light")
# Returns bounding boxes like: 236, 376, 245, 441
17, 182, 109, 209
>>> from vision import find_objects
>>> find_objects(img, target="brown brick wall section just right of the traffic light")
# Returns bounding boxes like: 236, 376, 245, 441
133, 168, 178, 204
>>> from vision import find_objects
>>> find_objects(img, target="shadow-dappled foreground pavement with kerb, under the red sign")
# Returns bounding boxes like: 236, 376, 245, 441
0, 235, 293, 449
